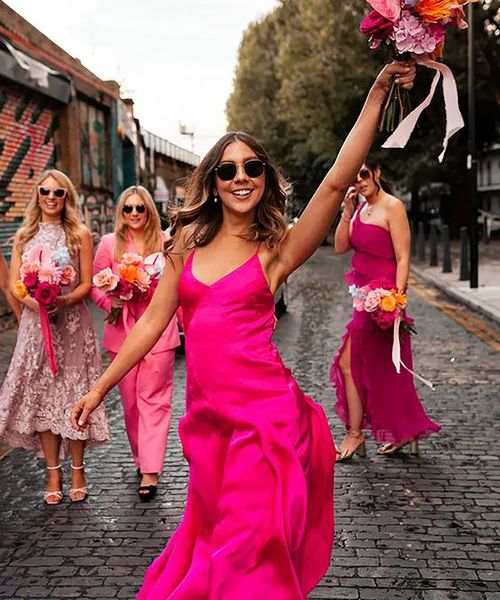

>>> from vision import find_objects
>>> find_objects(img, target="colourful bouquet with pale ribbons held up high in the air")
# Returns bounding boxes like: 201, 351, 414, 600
360, 0, 476, 161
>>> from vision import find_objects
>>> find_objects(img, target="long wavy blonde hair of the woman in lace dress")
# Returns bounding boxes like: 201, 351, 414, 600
17, 169, 82, 254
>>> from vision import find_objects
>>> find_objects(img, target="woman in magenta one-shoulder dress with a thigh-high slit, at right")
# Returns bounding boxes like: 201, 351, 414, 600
330, 161, 441, 460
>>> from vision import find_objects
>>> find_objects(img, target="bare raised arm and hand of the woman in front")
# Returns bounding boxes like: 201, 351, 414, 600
277, 62, 415, 279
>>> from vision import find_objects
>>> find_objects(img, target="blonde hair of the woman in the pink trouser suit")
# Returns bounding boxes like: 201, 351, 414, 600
115, 185, 164, 261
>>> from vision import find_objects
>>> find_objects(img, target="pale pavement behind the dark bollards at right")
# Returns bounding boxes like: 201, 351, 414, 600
412, 240, 500, 323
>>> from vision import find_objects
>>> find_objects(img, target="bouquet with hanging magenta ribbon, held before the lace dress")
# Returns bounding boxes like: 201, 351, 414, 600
16, 244, 76, 375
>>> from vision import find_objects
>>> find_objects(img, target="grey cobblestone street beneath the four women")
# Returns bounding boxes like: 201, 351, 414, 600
0, 248, 500, 600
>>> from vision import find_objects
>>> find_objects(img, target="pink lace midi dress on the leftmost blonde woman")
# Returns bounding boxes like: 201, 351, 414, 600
0, 223, 110, 458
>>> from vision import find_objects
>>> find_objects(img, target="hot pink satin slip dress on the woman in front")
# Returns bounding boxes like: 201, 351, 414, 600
138, 253, 335, 600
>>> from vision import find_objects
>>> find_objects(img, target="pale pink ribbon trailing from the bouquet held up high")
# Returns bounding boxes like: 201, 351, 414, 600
382, 57, 464, 162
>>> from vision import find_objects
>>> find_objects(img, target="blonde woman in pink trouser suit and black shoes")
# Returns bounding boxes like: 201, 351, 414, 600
92, 186, 179, 501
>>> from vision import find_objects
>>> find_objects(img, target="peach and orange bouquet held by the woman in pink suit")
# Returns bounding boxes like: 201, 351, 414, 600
93, 252, 165, 325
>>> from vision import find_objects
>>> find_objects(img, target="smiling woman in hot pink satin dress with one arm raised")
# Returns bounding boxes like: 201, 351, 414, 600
72, 63, 415, 600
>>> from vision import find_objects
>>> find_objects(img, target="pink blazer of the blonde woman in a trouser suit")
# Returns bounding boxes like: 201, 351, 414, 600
90, 233, 180, 353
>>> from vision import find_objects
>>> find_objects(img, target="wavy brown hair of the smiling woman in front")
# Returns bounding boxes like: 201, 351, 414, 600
165, 131, 290, 252
